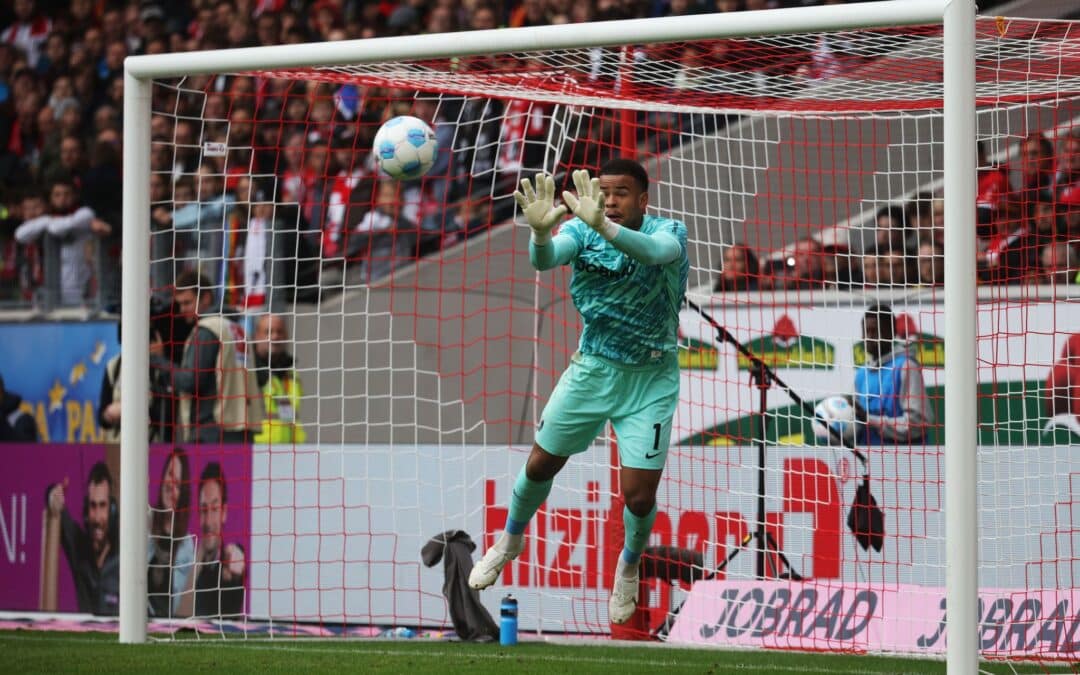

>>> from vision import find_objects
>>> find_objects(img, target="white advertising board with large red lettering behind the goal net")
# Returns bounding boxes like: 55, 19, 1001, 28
249, 446, 1080, 648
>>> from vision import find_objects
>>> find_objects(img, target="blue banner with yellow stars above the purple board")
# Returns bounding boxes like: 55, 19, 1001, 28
0, 321, 120, 443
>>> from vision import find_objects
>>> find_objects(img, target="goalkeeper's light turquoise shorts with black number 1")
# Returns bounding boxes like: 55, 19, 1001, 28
536, 353, 679, 470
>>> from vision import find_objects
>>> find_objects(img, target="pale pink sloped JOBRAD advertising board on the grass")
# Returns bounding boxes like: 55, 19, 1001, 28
670, 581, 1080, 659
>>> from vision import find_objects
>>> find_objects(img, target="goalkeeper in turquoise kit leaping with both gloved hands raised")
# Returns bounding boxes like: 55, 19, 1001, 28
469, 159, 690, 623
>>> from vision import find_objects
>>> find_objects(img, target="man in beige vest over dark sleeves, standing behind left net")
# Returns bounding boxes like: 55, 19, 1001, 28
151, 270, 265, 443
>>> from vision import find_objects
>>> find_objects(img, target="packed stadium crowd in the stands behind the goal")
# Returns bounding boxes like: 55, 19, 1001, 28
0, 0, 1080, 310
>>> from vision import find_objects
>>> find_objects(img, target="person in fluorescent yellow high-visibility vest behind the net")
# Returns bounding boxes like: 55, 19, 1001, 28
251, 314, 307, 443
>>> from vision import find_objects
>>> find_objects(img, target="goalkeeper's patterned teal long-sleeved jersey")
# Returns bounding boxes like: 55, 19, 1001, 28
555, 215, 690, 365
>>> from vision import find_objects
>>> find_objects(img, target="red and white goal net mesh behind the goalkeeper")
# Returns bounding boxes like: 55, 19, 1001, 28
139, 18, 1080, 660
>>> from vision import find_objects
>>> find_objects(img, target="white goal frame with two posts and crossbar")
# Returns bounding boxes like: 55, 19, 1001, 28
120, 0, 978, 673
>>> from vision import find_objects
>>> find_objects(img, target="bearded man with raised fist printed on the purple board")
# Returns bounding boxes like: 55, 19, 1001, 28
45, 462, 120, 617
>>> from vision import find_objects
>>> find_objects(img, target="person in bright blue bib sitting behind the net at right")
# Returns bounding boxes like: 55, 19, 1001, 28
852, 305, 933, 445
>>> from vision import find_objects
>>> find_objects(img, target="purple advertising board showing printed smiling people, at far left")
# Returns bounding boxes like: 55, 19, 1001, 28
0, 443, 252, 617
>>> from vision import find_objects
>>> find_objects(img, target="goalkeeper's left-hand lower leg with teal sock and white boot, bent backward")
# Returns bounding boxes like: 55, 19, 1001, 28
469, 444, 568, 590
